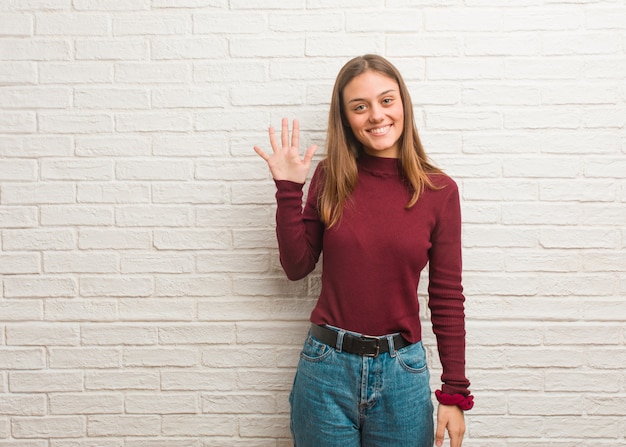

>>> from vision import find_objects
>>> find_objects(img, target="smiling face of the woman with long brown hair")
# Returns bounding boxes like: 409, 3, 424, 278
343, 70, 404, 158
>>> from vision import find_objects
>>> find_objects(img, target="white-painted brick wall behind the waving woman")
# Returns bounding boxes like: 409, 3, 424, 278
0, 0, 626, 447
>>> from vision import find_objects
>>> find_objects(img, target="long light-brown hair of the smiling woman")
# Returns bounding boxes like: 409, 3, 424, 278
318, 54, 442, 228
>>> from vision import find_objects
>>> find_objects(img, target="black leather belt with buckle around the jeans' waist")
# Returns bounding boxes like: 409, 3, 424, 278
311, 324, 411, 357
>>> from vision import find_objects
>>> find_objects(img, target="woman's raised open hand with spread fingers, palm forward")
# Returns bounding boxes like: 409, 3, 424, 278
254, 118, 317, 183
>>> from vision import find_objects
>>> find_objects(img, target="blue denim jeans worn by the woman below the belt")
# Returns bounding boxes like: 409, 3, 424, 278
289, 328, 434, 447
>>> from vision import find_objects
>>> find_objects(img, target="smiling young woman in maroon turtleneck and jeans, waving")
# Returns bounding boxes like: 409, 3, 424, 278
254, 55, 473, 447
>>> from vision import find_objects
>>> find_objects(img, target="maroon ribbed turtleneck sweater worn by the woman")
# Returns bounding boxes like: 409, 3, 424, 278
276, 154, 469, 395
